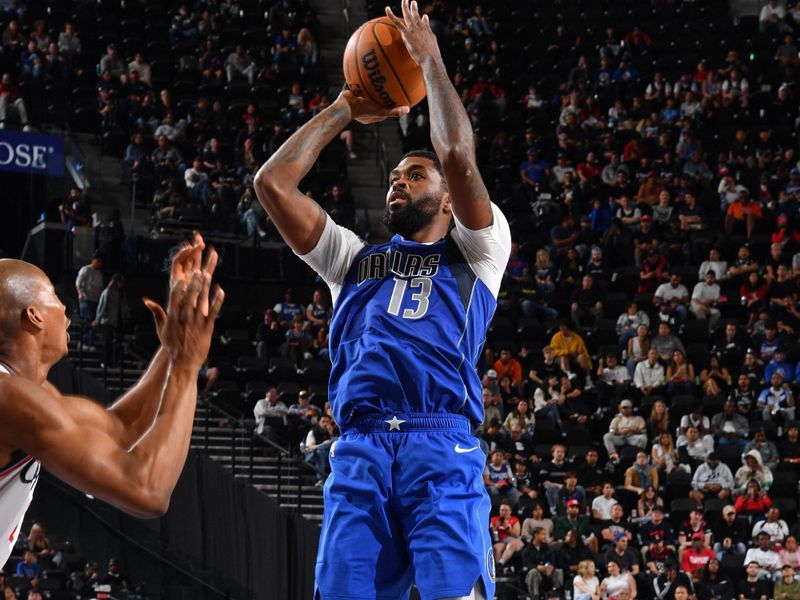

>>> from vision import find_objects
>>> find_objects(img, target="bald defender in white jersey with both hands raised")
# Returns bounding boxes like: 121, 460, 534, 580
0, 235, 224, 566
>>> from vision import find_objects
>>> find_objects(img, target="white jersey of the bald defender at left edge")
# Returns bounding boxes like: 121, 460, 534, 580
0, 364, 39, 565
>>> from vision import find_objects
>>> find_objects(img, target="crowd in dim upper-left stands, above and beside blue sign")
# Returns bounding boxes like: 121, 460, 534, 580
0, 0, 355, 239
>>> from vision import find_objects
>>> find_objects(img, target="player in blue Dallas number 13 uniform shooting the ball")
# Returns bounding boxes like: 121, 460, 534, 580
255, 0, 511, 600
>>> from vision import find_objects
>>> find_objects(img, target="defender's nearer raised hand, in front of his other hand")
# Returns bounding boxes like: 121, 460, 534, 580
147, 270, 225, 370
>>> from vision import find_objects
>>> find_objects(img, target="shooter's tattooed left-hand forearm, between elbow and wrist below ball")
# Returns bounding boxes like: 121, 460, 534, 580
256, 99, 352, 188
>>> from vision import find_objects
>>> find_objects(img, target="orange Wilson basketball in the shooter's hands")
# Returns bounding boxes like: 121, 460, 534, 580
343, 17, 425, 108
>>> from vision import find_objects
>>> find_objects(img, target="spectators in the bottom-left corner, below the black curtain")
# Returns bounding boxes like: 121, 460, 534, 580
0, 523, 138, 600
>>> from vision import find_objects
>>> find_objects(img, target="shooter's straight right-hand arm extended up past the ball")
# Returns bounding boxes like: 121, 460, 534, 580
386, 0, 492, 229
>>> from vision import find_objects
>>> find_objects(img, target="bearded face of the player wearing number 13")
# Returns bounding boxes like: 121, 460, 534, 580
383, 156, 447, 238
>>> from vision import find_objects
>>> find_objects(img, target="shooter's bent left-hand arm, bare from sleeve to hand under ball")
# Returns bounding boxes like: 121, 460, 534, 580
255, 90, 408, 254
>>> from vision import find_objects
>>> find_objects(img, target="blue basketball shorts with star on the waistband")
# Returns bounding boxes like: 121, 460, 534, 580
315, 414, 495, 600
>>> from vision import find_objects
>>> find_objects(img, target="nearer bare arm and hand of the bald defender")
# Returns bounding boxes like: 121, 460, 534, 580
0, 271, 224, 517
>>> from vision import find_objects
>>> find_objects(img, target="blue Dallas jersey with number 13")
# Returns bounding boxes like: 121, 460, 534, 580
329, 235, 497, 426
